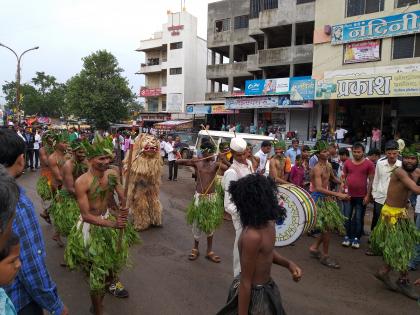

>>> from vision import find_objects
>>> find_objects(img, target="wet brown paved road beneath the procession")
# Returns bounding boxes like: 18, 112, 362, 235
19, 168, 420, 315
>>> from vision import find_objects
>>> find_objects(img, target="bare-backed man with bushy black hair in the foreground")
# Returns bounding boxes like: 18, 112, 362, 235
217, 175, 302, 315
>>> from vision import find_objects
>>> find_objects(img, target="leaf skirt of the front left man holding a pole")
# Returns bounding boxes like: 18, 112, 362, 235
64, 216, 140, 293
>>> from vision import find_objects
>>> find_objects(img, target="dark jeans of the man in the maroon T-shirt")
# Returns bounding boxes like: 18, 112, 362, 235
343, 197, 365, 239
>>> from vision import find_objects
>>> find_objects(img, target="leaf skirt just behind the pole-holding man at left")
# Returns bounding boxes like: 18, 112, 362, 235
49, 189, 80, 236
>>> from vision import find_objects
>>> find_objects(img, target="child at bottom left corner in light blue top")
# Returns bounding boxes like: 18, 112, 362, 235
0, 234, 20, 315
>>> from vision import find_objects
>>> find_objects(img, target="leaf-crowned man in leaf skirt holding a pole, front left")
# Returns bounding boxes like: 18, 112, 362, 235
64, 136, 138, 315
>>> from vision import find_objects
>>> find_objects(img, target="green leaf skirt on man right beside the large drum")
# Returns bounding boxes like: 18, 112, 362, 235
311, 192, 346, 233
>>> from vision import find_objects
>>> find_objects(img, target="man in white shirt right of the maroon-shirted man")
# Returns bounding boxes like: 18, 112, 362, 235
371, 140, 401, 231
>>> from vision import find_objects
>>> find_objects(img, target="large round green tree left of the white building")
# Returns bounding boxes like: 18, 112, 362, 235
66, 50, 134, 129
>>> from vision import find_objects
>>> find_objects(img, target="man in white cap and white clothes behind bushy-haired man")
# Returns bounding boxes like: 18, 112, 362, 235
222, 138, 252, 277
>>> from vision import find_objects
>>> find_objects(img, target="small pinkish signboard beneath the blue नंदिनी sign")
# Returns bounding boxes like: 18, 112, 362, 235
344, 39, 381, 64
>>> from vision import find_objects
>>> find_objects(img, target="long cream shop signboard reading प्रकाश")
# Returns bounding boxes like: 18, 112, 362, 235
315, 72, 420, 99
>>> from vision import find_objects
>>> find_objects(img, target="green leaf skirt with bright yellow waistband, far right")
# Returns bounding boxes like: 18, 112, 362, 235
370, 204, 420, 272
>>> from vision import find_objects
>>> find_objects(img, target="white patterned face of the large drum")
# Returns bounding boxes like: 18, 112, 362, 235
275, 185, 306, 246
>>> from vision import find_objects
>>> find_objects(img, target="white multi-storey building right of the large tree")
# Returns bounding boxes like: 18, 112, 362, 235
137, 11, 207, 121
